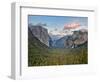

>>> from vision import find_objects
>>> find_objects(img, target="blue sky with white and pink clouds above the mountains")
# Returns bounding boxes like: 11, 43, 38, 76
28, 15, 88, 34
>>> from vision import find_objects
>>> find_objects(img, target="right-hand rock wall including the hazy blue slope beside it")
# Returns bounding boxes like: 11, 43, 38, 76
55, 30, 88, 48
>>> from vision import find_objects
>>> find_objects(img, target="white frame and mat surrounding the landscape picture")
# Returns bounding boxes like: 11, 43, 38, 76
12, 3, 96, 79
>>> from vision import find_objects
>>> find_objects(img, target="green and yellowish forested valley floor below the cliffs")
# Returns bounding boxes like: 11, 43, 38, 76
28, 47, 88, 66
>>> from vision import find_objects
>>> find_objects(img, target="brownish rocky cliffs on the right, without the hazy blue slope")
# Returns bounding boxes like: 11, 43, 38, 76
65, 29, 88, 48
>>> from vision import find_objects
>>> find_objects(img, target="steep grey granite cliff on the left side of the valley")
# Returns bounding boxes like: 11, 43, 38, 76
29, 25, 49, 46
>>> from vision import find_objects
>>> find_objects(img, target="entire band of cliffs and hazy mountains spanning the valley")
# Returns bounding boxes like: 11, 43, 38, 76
29, 25, 88, 48
